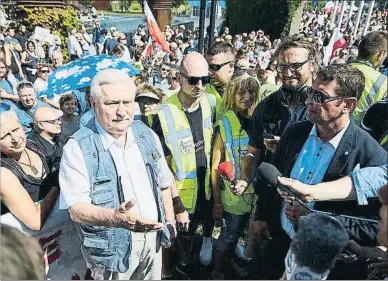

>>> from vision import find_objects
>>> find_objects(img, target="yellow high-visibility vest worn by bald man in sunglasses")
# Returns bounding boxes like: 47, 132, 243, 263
156, 94, 215, 213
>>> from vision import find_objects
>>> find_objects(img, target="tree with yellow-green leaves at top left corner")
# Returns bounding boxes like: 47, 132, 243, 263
13, 6, 80, 61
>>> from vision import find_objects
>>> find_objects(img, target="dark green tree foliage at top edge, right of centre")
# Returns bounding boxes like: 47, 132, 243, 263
226, 0, 301, 39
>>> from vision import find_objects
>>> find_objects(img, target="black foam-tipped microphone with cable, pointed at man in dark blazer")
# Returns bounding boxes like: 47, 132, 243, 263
256, 162, 378, 223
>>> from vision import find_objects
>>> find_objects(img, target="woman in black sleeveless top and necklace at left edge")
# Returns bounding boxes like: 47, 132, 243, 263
0, 103, 59, 231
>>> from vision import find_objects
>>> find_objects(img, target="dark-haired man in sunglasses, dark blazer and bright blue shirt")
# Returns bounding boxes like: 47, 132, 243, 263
254, 65, 387, 279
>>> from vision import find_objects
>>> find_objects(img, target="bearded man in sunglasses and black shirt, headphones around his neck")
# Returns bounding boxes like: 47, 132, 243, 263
234, 36, 317, 199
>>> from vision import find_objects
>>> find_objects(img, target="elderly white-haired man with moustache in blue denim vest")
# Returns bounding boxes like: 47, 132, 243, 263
59, 69, 175, 280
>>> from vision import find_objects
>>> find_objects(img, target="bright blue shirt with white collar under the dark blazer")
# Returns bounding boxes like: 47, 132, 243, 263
281, 121, 350, 239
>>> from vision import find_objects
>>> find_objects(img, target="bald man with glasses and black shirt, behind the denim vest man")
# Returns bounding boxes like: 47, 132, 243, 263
28, 107, 65, 170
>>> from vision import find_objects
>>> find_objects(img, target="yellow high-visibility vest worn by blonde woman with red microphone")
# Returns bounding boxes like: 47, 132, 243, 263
217, 111, 254, 215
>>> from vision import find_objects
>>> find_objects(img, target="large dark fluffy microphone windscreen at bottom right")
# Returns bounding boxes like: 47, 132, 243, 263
290, 213, 349, 274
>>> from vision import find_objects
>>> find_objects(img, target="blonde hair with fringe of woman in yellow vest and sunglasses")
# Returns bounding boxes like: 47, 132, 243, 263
222, 77, 260, 115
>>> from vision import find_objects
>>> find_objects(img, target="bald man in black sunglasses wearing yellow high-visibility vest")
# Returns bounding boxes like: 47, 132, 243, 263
150, 52, 215, 277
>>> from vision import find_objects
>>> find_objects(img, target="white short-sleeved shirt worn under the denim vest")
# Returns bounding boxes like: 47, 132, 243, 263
59, 118, 172, 220
